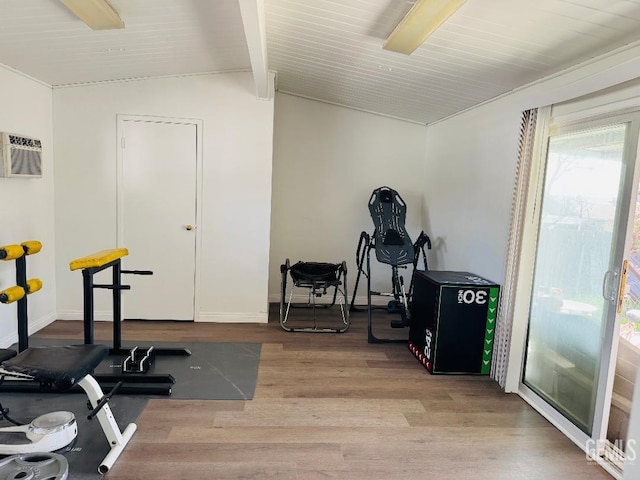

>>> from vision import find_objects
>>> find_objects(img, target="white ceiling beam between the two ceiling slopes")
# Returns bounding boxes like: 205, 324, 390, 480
240, 0, 273, 100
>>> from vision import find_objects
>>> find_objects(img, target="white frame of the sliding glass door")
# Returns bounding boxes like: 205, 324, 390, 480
505, 106, 640, 478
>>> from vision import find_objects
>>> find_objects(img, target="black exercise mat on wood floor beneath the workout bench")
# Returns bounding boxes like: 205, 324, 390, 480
0, 338, 261, 480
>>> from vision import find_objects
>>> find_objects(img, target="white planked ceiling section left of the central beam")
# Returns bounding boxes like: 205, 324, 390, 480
0, 0, 250, 85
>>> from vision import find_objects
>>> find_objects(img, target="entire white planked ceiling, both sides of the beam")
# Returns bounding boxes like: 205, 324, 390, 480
0, 0, 640, 123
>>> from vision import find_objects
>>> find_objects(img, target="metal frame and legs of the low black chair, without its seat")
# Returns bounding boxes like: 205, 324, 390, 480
280, 258, 350, 333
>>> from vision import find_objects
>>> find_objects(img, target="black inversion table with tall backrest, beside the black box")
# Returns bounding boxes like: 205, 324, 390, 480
351, 187, 431, 343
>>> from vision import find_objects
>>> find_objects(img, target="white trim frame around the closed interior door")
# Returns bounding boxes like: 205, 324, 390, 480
116, 114, 204, 322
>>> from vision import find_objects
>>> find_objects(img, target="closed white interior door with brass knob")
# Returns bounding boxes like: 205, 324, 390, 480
118, 117, 198, 320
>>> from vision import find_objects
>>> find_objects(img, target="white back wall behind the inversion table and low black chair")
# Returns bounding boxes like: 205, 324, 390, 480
269, 94, 426, 301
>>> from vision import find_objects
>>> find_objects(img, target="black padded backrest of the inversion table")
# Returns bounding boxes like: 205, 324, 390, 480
369, 187, 414, 265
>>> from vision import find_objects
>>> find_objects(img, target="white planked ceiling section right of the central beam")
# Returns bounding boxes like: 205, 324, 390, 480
266, 0, 640, 123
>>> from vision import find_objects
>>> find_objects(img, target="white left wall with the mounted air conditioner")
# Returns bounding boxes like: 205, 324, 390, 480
0, 67, 56, 347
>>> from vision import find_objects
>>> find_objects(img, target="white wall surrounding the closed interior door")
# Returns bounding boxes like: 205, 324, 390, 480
53, 72, 273, 322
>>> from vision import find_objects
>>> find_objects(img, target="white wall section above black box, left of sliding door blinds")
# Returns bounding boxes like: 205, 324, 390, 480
424, 104, 521, 282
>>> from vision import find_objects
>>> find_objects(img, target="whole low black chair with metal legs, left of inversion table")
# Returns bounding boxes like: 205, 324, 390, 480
280, 258, 349, 333
